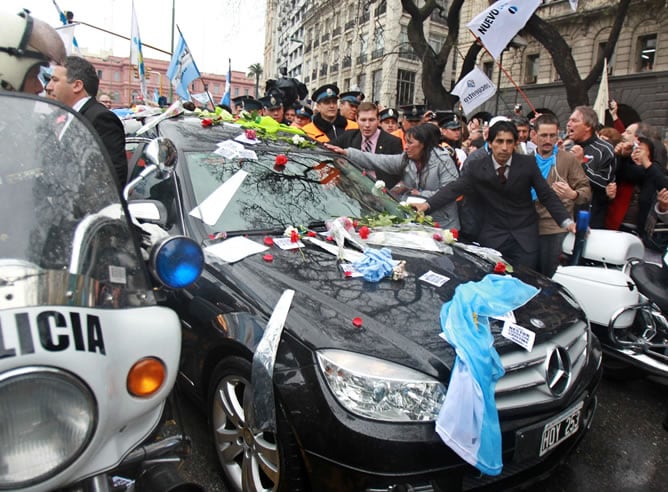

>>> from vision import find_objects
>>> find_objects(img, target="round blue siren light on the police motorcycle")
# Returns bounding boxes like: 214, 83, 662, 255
151, 236, 204, 289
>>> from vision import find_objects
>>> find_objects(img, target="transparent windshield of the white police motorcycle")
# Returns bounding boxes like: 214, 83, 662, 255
0, 92, 154, 309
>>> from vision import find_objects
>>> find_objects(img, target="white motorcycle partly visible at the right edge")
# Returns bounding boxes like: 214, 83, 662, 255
552, 212, 668, 381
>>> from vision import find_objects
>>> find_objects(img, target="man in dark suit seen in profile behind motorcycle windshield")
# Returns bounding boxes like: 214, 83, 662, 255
46, 56, 128, 190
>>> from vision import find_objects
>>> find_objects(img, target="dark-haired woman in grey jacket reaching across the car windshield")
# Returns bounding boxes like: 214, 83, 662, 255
326, 124, 459, 229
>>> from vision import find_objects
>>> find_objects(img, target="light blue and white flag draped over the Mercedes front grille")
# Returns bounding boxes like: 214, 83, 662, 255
436, 274, 538, 476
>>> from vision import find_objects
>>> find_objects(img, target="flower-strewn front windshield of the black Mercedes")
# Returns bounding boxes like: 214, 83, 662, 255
159, 119, 403, 233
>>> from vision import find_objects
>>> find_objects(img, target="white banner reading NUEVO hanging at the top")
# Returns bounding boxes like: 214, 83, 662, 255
466, 0, 542, 60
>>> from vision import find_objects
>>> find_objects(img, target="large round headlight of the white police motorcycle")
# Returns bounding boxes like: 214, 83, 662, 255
0, 367, 97, 490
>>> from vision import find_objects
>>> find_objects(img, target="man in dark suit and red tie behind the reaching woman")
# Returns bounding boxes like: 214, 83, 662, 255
332, 102, 404, 189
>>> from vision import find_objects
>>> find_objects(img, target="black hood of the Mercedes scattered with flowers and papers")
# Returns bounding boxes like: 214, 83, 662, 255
204, 237, 584, 377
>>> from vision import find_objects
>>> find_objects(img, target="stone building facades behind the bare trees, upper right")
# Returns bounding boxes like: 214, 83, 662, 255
264, 0, 668, 133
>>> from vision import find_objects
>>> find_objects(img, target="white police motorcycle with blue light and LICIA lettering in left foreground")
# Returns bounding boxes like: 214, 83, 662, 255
0, 92, 203, 492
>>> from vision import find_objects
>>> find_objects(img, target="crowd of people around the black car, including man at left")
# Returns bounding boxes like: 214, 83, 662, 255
0, 8, 668, 276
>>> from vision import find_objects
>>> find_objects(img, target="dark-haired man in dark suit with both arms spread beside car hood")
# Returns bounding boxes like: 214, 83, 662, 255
414, 121, 575, 269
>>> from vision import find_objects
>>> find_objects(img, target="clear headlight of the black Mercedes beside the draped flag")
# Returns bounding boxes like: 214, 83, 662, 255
317, 350, 446, 422
